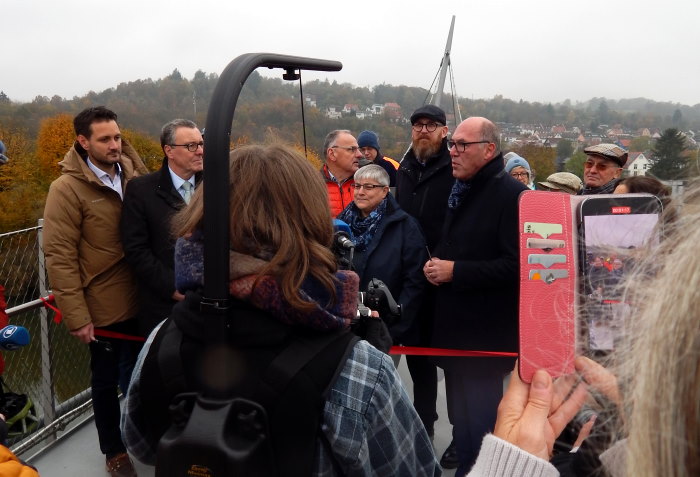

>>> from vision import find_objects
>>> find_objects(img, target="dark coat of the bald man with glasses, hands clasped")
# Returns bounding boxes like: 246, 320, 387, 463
432, 154, 527, 351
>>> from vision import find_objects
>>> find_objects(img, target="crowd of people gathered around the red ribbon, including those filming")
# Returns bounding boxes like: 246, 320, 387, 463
35, 105, 700, 477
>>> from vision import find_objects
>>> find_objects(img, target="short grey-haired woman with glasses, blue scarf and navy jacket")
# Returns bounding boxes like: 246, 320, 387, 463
338, 164, 428, 356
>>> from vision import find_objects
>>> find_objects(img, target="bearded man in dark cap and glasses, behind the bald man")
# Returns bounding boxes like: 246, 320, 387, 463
396, 105, 459, 468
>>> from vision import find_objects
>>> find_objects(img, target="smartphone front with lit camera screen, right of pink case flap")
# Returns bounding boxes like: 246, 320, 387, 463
580, 195, 661, 352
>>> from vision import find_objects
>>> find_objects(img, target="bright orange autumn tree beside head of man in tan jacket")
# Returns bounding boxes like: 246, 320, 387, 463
36, 114, 75, 183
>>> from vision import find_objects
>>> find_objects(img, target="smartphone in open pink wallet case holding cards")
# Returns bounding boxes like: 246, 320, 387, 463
519, 191, 662, 382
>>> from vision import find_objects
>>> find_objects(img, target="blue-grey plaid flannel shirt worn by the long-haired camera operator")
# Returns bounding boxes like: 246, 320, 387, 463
121, 326, 442, 477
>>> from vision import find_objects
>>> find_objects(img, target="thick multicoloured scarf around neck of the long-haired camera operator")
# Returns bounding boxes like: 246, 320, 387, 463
175, 233, 360, 330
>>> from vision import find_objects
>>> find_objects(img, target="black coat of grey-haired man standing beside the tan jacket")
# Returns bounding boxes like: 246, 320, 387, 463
120, 159, 199, 336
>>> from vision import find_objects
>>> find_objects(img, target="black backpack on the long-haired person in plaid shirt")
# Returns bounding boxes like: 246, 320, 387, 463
141, 296, 359, 477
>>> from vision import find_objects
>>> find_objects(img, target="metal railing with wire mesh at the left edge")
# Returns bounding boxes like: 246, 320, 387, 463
0, 220, 92, 454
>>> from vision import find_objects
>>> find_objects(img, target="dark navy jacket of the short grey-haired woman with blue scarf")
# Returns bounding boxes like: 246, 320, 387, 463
355, 194, 428, 344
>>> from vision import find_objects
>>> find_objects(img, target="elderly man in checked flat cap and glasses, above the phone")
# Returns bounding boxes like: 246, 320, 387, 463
579, 144, 627, 195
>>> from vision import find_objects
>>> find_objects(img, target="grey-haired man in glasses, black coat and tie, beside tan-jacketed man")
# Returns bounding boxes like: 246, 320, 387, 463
121, 119, 204, 336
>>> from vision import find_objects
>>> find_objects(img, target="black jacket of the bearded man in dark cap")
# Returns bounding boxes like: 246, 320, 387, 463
396, 140, 455, 251
